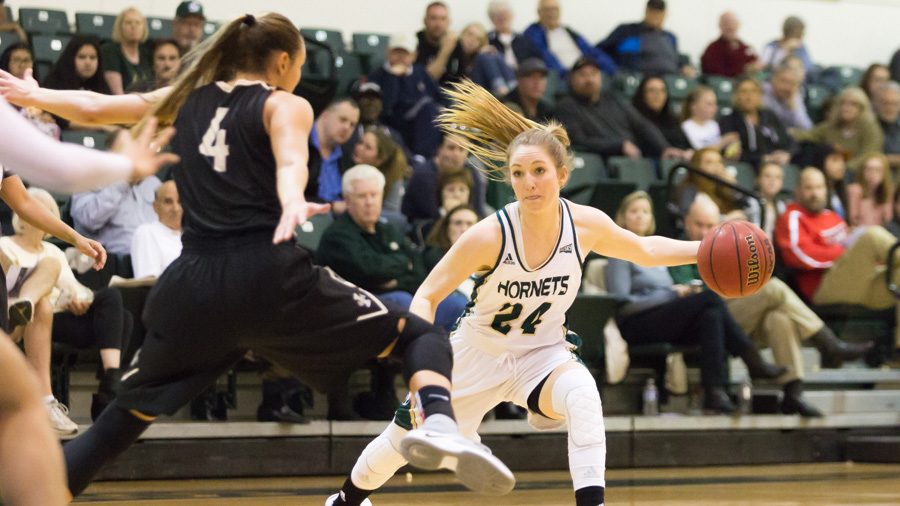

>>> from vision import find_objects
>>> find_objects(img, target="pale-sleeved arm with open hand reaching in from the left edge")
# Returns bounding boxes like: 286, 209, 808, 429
0, 99, 178, 193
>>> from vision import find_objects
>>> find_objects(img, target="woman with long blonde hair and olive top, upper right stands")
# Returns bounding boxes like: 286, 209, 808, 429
796, 86, 884, 174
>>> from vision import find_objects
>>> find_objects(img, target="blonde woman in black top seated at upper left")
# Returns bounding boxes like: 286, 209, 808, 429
102, 7, 153, 95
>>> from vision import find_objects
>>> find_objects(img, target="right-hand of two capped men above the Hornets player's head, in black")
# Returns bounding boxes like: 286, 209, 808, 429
556, 57, 676, 158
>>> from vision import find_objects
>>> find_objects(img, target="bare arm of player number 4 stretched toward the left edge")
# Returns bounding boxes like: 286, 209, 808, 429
0, 70, 171, 125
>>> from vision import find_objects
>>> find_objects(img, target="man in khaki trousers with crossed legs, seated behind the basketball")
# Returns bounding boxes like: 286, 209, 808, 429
669, 194, 871, 417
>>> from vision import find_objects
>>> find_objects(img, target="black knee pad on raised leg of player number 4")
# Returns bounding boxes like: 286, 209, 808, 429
394, 314, 453, 383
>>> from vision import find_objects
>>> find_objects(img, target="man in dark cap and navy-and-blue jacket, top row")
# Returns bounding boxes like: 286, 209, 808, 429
597, 0, 697, 76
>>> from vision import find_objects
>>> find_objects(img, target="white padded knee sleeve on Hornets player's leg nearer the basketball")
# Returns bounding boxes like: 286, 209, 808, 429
553, 367, 606, 490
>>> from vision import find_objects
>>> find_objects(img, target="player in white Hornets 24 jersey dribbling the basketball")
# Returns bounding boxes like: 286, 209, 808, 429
326, 81, 700, 506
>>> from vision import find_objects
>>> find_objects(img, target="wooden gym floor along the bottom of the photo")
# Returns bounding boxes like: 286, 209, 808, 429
76, 462, 900, 506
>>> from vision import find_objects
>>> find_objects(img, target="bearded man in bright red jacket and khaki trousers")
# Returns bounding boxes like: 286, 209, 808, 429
775, 167, 900, 348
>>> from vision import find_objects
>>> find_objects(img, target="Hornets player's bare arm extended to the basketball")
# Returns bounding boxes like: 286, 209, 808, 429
572, 205, 700, 267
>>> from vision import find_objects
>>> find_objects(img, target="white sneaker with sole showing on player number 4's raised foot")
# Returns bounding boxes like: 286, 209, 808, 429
400, 414, 516, 495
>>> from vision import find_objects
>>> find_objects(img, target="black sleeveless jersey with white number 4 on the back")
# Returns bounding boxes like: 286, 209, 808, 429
172, 82, 281, 240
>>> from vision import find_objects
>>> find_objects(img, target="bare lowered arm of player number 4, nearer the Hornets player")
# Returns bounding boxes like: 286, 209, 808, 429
263, 91, 331, 244
